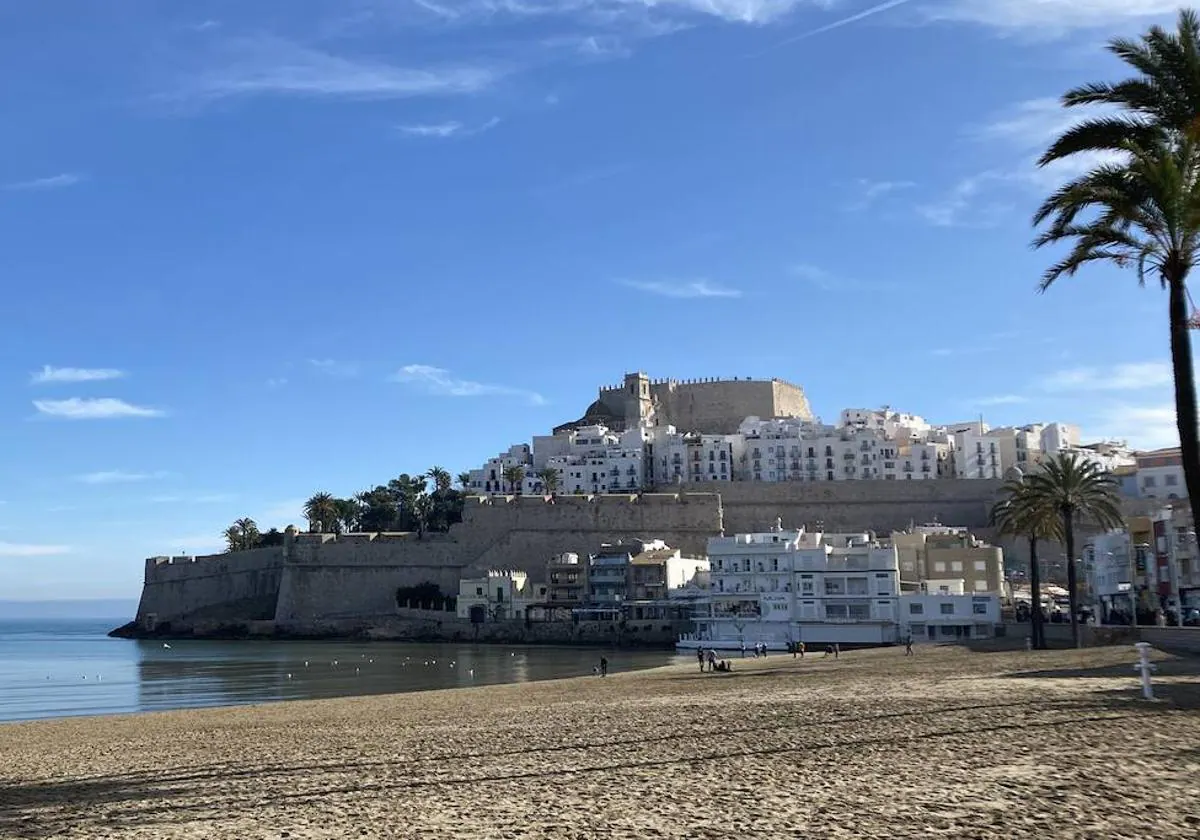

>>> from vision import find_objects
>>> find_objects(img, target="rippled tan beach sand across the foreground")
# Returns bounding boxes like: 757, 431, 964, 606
0, 647, 1200, 840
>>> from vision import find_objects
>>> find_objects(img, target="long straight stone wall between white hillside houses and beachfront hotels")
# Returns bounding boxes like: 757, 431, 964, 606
694, 480, 1002, 534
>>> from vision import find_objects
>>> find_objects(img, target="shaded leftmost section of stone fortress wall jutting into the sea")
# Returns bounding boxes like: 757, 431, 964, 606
137, 547, 283, 622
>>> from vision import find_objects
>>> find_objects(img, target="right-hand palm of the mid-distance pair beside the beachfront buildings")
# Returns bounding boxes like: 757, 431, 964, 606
1026, 452, 1124, 647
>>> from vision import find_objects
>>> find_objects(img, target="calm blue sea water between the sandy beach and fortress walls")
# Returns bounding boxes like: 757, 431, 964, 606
0, 619, 690, 720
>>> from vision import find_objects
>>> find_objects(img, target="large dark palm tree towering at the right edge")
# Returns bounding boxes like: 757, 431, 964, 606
1033, 10, 1200, 535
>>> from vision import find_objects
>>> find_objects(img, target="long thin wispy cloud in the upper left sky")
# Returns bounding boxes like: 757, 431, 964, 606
175, 37, 503, 100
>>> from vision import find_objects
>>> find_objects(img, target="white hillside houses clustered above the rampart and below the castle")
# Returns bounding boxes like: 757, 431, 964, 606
467, 373, 1183, 498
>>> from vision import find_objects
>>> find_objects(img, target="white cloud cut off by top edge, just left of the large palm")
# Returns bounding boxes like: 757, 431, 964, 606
920, 0, 1180, 37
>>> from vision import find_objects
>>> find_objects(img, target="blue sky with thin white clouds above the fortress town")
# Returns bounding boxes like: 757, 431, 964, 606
0, 0, 1190, 599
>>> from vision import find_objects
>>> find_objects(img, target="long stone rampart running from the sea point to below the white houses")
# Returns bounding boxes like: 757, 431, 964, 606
131, 480, 1032, 632
